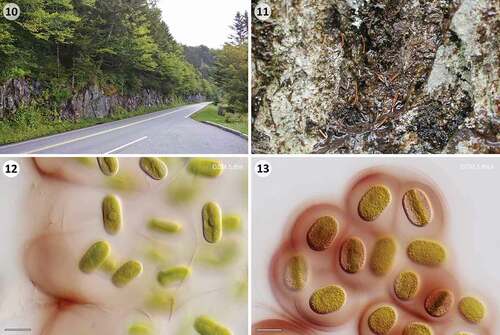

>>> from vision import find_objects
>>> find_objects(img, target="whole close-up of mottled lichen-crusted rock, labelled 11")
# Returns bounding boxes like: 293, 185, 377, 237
252, 0, 500, 153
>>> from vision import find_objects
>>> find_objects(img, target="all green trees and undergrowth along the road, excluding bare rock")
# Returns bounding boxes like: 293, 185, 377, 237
0, 0, 248, 144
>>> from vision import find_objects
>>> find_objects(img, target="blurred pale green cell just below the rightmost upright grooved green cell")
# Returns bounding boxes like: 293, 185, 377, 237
196, 240, 241, 267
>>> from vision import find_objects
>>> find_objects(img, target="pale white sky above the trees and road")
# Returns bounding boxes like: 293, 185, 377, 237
158, 0, 250, 48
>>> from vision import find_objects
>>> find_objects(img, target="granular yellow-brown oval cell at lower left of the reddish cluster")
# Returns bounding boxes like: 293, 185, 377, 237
309, 285, 346, 314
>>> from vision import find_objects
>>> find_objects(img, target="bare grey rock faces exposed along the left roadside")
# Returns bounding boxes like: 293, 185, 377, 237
0, 79, 205, 120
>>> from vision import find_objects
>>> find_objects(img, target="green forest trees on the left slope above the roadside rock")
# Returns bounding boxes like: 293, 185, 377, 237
0, 0, 214, 99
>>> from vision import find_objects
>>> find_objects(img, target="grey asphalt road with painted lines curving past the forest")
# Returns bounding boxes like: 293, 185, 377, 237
0, 103, 248, 155
